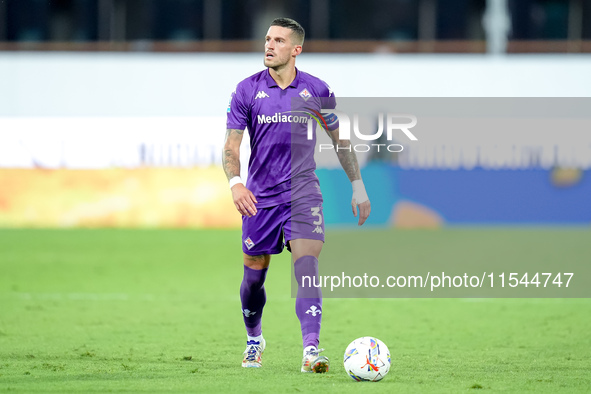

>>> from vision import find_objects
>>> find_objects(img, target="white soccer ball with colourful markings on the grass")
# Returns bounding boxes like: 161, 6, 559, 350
343, 337, 390, 382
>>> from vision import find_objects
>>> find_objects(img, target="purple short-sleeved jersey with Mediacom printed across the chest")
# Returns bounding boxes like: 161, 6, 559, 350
226, 69, 336, 208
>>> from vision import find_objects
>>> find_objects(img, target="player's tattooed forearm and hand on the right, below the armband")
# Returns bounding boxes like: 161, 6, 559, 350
327, 128, 371, 226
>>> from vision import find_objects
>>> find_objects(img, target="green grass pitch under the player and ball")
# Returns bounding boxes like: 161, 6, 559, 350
0, 228, 591, 393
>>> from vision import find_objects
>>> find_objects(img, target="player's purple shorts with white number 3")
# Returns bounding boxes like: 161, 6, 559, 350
242, 196, 324, 256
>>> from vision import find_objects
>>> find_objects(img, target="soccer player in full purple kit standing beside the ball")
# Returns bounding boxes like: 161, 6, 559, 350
223, 18, 371, 372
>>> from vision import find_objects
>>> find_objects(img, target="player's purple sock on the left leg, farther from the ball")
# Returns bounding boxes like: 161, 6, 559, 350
240, 266, 267, 337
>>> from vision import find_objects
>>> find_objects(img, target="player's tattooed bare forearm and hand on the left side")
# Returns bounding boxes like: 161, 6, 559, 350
222, 129, 257, 217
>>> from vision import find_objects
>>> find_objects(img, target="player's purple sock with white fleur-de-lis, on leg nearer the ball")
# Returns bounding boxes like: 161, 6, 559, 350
294, 256, 322, 348
